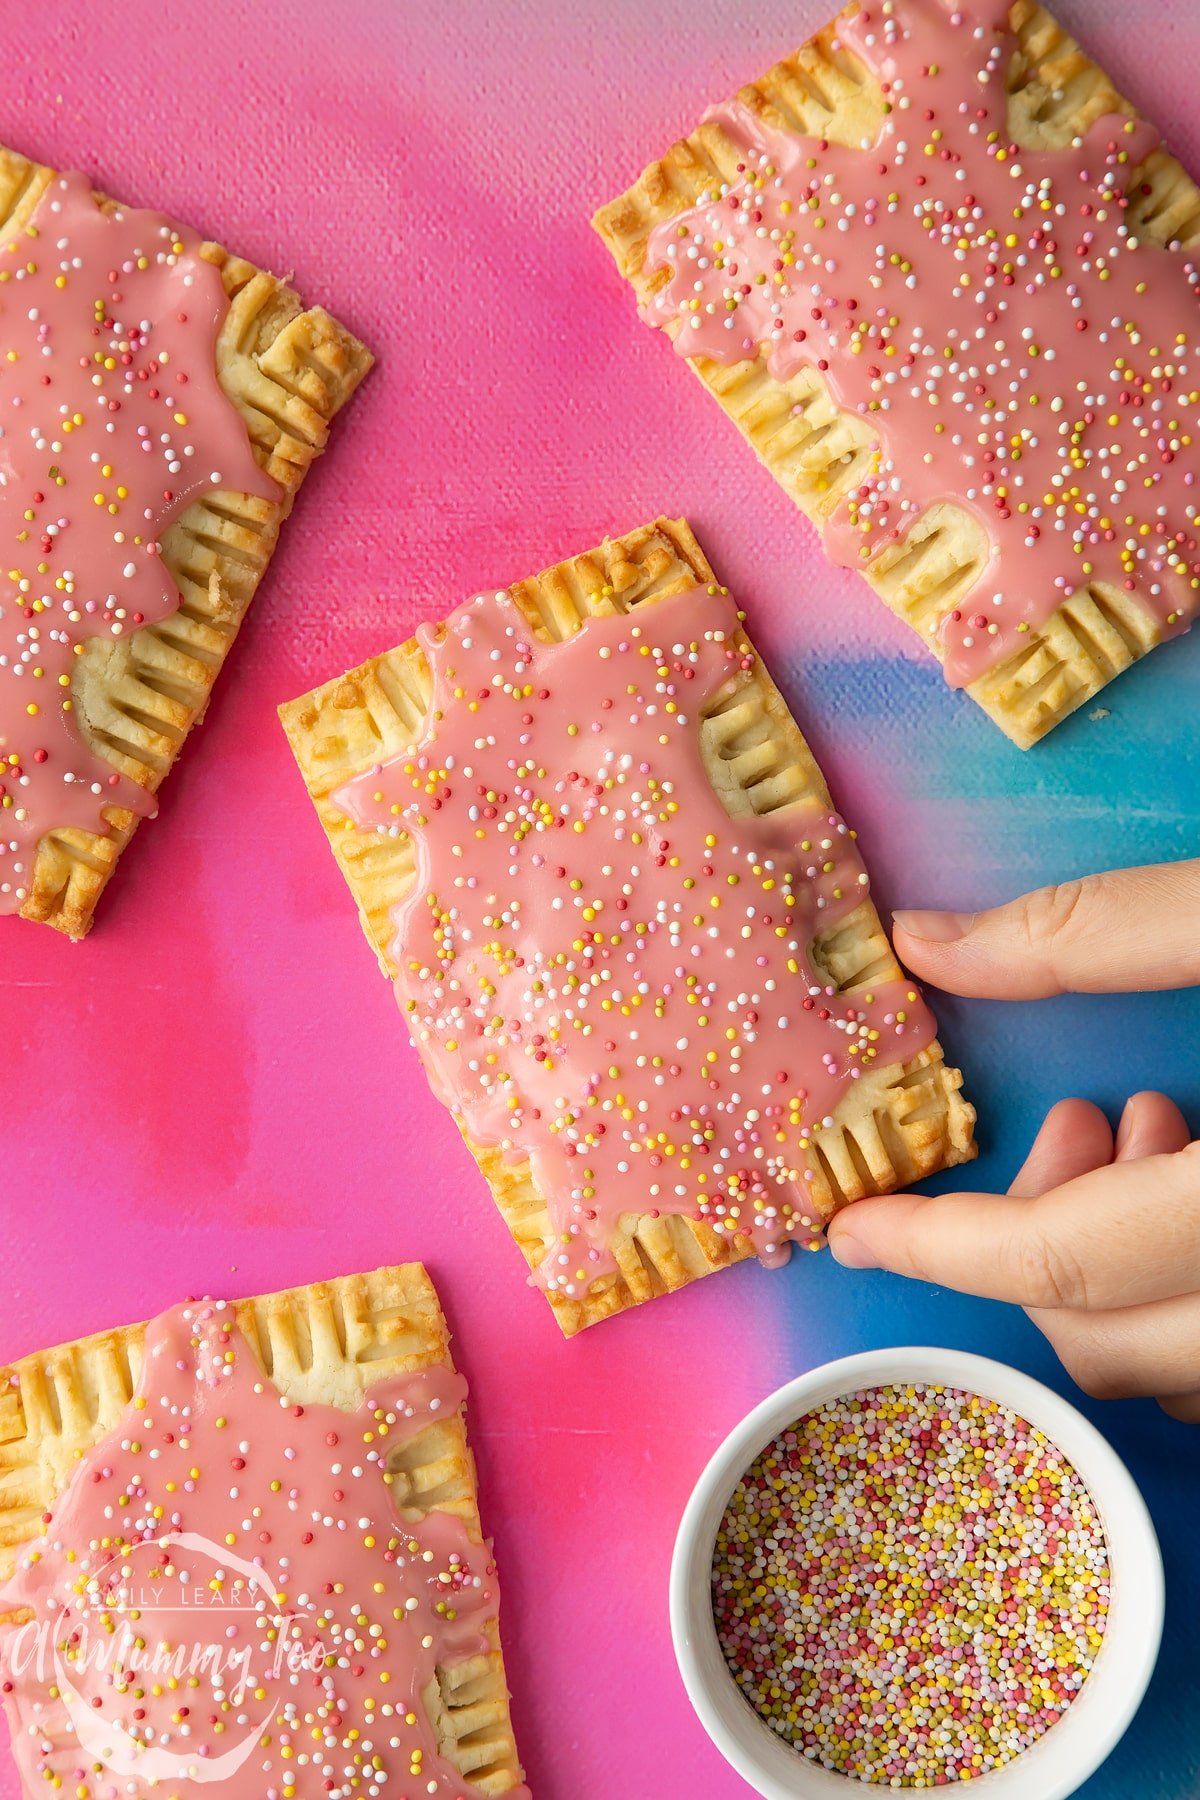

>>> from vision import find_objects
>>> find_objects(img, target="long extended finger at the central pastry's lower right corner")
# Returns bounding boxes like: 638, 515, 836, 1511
829, 1143, 1200, 1310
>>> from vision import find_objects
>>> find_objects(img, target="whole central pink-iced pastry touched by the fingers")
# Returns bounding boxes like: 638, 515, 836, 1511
281, 518, 973, 1336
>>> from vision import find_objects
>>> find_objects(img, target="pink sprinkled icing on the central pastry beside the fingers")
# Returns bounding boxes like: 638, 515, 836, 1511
335, 590, 934, 1296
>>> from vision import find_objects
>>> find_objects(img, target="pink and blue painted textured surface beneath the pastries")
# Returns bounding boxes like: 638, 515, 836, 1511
0, 0, 1200, 1800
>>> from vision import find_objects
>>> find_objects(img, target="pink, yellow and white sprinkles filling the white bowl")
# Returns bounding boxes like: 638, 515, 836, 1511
712, 1382, 1110, 1787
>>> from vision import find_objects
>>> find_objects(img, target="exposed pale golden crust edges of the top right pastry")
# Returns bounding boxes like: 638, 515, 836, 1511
594, 0, 1200, 749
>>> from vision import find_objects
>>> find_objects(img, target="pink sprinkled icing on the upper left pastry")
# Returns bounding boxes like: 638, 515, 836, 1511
0, 175, 279, 913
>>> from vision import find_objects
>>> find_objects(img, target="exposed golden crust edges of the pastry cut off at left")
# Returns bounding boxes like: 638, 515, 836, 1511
0, 146, 372, 938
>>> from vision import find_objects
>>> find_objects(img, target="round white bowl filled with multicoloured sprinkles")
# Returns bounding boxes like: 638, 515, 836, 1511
671, 1348, 1164, 1800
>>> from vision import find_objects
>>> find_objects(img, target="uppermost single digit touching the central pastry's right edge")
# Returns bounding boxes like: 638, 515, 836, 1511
894, 860, 1200, 1001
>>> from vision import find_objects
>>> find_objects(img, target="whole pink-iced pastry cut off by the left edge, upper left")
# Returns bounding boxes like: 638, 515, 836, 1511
0, 148, 371, 938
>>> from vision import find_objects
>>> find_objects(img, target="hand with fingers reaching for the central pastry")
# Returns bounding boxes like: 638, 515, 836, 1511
829, 862, 1200, 1422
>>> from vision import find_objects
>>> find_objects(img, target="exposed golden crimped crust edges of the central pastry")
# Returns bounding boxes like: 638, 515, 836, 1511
281, 518, 975, 1337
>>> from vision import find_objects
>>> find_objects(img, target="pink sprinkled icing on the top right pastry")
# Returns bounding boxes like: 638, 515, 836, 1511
644, 0, 1200, 686
